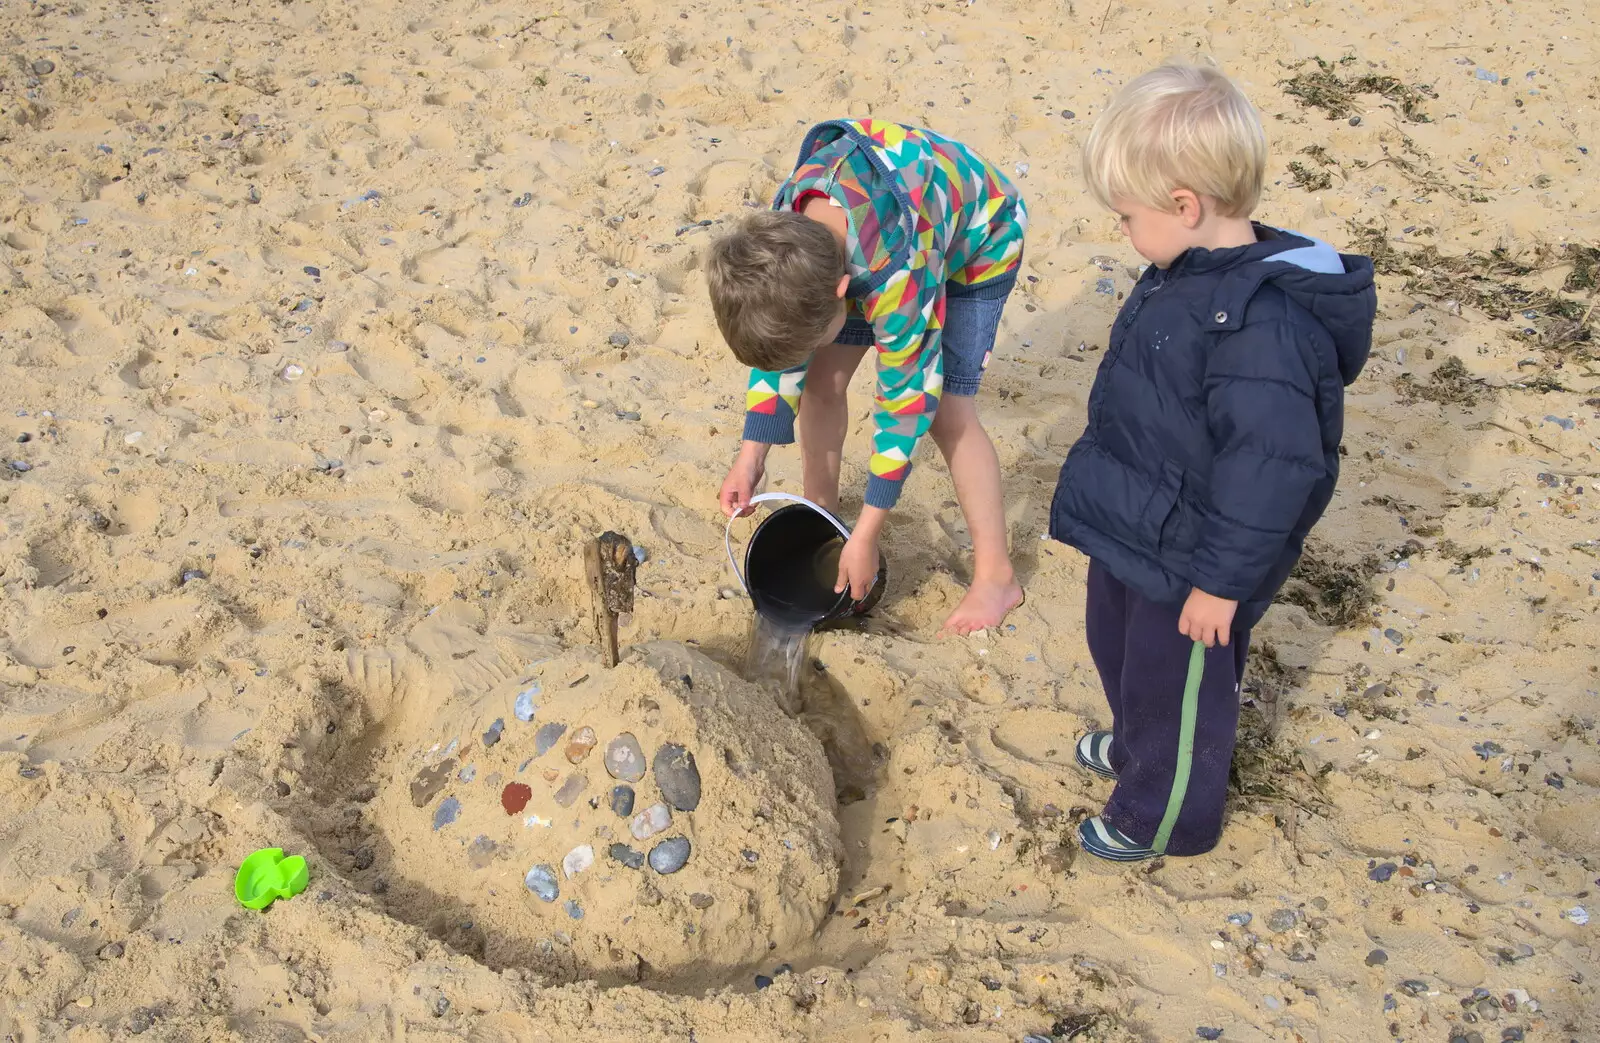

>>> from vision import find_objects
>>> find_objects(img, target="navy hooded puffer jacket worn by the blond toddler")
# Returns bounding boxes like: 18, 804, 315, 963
1050, 226, 1378, 630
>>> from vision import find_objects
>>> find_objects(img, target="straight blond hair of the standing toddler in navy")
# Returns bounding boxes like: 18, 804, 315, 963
1083, 61, 1267, 218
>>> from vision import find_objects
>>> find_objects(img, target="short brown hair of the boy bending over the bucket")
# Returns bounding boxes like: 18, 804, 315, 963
706, 210, 845, 371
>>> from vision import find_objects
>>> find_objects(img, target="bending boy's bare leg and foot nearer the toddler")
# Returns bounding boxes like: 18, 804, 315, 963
934, 387, 1022, 633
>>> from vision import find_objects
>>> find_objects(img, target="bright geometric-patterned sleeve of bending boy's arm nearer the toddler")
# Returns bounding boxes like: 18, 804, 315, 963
866, 253, 944, 510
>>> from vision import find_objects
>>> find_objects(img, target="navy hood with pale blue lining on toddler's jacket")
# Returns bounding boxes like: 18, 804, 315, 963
1173, 224, 1378, 386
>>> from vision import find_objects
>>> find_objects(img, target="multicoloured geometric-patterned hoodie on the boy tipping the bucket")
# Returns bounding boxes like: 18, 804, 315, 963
744, 120, 1027, 509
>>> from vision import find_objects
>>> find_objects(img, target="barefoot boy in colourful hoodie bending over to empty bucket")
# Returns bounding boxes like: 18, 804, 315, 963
707, 120, 1027, 633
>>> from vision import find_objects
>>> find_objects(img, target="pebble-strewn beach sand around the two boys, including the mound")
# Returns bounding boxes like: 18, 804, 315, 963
0, 0, 1600, 1043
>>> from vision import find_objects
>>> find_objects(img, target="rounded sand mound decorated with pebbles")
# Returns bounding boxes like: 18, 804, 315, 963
370, 641, 840, 979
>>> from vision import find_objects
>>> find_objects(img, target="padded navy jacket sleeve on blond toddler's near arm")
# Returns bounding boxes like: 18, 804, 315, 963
1189, 323, 1326, 601
